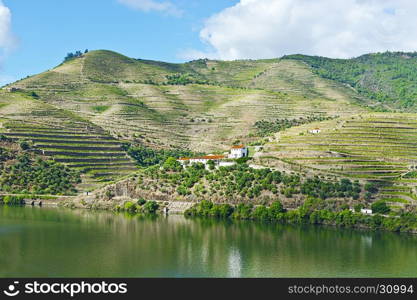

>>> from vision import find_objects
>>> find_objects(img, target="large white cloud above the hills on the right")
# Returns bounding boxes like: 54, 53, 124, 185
183, 0, 417, 59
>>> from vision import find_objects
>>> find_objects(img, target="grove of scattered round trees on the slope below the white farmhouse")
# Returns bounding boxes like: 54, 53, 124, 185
139, 158, 363, 202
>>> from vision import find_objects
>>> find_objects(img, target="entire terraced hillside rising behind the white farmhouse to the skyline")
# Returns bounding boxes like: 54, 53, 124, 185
0, 50, 417, 210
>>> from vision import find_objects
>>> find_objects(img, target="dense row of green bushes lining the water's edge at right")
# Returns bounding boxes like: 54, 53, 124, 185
185, 198, 417, 232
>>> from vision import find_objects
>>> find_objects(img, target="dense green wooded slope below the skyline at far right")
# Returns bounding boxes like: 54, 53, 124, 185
284, 52, 417, 111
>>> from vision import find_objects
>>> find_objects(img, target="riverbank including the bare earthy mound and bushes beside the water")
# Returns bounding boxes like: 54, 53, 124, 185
3, 178, 417, 234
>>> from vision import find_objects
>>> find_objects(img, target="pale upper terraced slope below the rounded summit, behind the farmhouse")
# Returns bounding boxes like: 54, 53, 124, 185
11, 51, 365, 151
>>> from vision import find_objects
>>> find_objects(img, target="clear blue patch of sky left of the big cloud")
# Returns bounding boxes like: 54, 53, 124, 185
0, 0, 237, 81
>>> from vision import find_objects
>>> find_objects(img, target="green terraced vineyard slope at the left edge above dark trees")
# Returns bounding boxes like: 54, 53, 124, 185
0, 93, 136, 191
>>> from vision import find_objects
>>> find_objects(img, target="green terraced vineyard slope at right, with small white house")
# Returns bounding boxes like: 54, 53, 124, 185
264, 113, 417, 205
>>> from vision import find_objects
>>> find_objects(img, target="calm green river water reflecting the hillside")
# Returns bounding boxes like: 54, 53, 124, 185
0, 206, 417, 277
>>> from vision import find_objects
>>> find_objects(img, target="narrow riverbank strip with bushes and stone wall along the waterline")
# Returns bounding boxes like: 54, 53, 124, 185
0, 197, 417, 234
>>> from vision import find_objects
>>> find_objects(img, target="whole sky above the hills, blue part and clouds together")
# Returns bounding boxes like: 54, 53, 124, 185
0, 0, 417, 85
